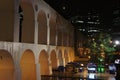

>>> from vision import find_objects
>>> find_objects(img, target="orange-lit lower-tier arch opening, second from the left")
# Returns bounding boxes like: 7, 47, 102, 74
20, 49, 36, 80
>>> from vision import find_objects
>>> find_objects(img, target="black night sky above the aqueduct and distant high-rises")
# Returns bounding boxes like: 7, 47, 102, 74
44, 0, 119, 30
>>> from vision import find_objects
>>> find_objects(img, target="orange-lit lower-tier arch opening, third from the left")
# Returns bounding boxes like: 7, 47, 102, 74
39, 50, 50, 75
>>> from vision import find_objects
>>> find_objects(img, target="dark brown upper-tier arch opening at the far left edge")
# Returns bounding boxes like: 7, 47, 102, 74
0, 0, 15, 42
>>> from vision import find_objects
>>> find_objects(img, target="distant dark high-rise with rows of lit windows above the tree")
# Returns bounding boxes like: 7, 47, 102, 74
71, 12, 103, 37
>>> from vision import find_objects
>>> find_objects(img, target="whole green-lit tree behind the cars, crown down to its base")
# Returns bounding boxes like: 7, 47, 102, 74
90, 33, 115, 63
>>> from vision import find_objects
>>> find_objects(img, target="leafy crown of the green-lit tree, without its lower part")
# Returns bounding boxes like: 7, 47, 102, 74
90, 33, 115, 53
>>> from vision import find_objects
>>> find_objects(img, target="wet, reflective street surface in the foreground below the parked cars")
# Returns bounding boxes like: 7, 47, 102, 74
41, 69, 116, 80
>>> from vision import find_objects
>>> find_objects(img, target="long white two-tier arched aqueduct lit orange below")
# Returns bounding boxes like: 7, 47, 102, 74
0, 0, 74, 80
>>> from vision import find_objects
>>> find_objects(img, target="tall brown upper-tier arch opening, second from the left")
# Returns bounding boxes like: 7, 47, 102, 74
20, 0, 35, 43
